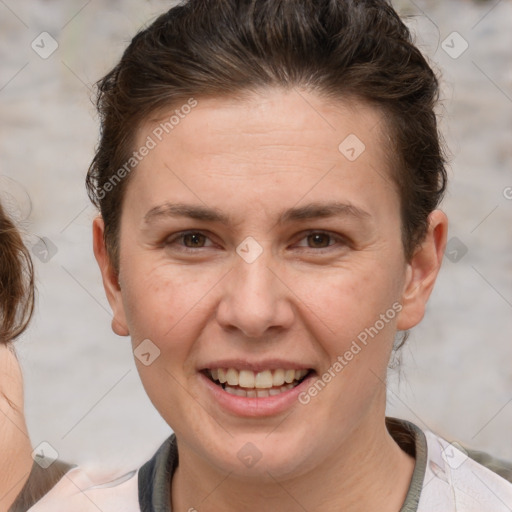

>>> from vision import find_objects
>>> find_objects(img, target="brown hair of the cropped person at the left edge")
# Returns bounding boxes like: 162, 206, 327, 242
0, 204, 34, 343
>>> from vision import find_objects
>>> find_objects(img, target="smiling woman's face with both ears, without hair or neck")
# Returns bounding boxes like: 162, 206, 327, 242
95, 89, 443, 478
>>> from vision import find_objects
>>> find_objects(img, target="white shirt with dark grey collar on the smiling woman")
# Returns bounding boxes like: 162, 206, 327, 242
29, 419, 512, 512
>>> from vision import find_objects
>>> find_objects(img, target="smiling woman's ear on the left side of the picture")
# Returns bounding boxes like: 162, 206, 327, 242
92, 216, 130, 336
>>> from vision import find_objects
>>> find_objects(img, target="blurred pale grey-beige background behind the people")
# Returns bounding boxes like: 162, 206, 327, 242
0, 0, 512, 467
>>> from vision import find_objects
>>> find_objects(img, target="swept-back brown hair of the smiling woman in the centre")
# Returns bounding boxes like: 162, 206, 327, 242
87, 0, 446, 268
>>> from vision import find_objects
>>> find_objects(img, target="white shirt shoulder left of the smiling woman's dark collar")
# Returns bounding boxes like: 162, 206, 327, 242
25, 467, 140, 512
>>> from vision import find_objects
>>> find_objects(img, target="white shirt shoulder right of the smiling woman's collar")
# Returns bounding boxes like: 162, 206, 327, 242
418, 431, 512, 512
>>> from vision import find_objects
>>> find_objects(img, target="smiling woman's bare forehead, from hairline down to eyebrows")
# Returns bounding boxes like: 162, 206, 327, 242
128, 89, 397, 222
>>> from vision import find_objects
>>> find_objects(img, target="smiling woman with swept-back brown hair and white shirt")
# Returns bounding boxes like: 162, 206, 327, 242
29, 0, 512, 512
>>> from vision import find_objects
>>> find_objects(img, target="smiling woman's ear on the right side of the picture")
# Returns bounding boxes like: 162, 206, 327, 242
397, 210, 448, 331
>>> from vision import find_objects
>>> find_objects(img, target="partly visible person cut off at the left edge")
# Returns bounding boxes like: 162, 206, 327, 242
0, 204, 74, 512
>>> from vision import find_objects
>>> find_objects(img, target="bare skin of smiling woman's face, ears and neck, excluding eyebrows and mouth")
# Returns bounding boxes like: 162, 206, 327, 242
93, 89, 447, 511
